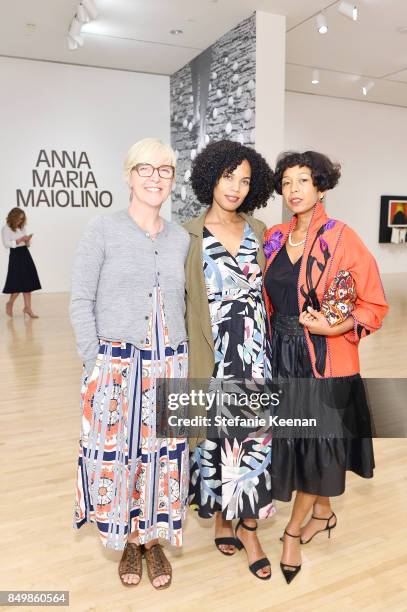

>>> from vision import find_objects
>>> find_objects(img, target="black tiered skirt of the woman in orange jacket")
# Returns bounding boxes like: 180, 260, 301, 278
272, 313, 374, 501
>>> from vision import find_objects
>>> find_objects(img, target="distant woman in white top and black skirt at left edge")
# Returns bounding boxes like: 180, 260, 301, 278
1, 207, 41, 319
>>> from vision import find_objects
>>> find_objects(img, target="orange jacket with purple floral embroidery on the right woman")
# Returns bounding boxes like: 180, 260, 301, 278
263, 202, 388, 378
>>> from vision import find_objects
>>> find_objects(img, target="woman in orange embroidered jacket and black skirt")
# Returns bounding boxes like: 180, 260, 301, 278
264, 151, 388, 583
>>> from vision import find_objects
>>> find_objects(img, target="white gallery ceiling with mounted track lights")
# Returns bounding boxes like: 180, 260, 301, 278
0, 0, 407, 107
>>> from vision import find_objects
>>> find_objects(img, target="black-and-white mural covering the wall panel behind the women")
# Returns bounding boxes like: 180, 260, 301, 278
170, 14, 256, 223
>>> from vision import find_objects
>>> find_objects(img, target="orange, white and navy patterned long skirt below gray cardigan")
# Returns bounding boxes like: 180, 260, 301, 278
74, 288, 189, 550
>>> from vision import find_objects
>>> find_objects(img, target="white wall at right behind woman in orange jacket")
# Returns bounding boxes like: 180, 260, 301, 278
285, 92, 407, 273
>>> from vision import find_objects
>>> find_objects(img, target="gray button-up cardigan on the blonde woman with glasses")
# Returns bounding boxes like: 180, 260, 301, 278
70, 210, 189, 374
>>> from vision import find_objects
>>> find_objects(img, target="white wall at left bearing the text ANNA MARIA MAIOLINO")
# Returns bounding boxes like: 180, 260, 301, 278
0, 58, 170, 292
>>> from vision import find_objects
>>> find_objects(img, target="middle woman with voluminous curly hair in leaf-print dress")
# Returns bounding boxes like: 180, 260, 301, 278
185, 140, 274, 580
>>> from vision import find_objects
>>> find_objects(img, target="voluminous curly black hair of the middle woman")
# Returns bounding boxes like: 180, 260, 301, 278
191, 140, 274, 213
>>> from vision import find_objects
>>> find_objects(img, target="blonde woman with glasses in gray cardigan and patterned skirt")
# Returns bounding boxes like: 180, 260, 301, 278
71, 138, 189, 589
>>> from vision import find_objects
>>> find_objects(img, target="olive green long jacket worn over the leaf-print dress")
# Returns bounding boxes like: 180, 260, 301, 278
184, 211, 266, 447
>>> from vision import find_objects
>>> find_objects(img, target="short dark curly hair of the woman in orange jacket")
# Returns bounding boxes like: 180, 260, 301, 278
274, 151, 341, 195
